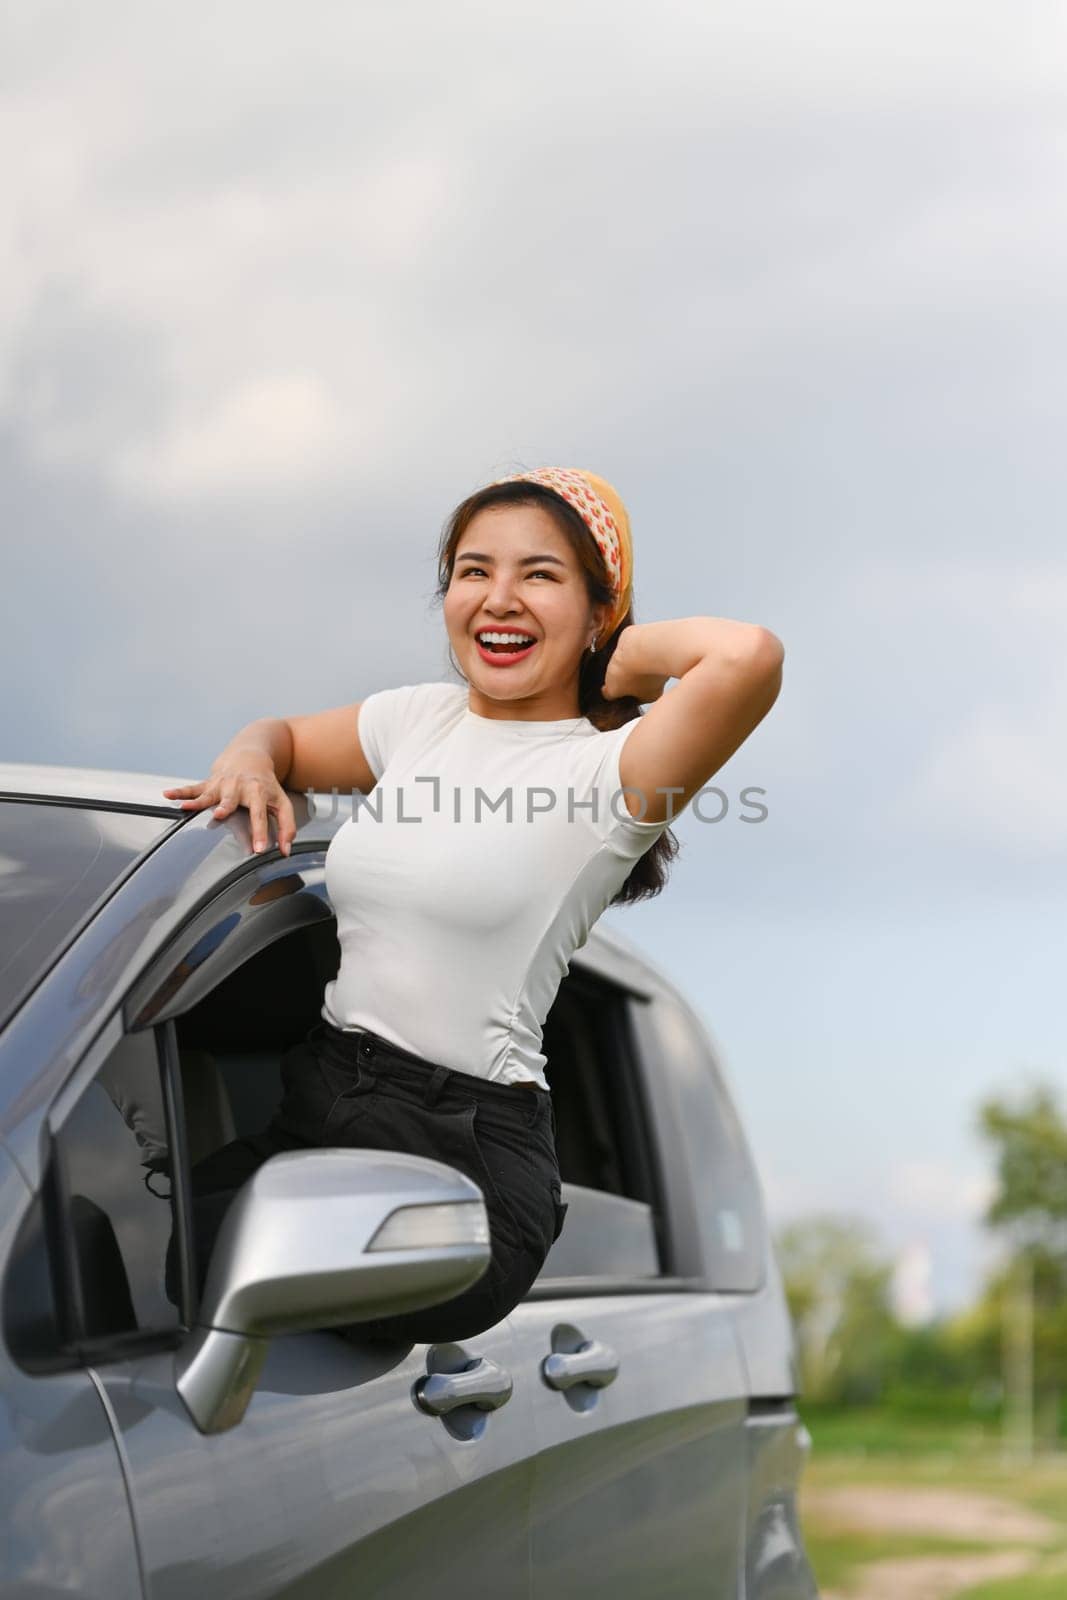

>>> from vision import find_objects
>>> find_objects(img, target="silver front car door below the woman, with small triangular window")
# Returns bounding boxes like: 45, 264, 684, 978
39, 1018, 531, 1600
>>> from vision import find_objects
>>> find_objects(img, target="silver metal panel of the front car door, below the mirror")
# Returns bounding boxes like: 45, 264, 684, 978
106, 1325, 531, 1600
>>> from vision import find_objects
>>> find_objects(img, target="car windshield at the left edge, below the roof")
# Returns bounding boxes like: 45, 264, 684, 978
0, 800, 174, 1027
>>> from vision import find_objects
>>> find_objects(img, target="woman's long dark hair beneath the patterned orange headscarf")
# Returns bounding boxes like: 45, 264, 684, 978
435, 483, 680, 906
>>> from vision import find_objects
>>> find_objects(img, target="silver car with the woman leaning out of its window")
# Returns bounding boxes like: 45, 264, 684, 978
0, 765, 817, 1600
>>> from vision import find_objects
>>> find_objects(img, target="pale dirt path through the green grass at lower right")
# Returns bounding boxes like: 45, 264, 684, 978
801, 1485, 1061, 1600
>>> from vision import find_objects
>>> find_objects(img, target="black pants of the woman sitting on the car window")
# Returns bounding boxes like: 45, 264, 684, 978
177, 1021, 566, 1344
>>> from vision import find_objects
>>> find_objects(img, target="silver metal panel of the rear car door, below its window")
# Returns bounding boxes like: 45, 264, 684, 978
512, 1286, 745, 1600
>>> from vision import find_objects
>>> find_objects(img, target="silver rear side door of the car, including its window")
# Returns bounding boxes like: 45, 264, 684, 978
512, 970, 745, 1600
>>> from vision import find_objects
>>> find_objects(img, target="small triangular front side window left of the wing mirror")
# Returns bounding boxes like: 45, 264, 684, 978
5, 1030, 182, 1365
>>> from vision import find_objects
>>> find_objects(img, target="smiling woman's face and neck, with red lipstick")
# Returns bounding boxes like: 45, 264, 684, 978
445, 506, 605, 720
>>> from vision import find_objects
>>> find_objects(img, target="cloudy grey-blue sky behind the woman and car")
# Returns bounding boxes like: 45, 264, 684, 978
0, 0, 1067, 1310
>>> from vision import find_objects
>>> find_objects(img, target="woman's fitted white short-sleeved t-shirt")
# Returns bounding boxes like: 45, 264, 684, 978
322, 683, 681, 1088
